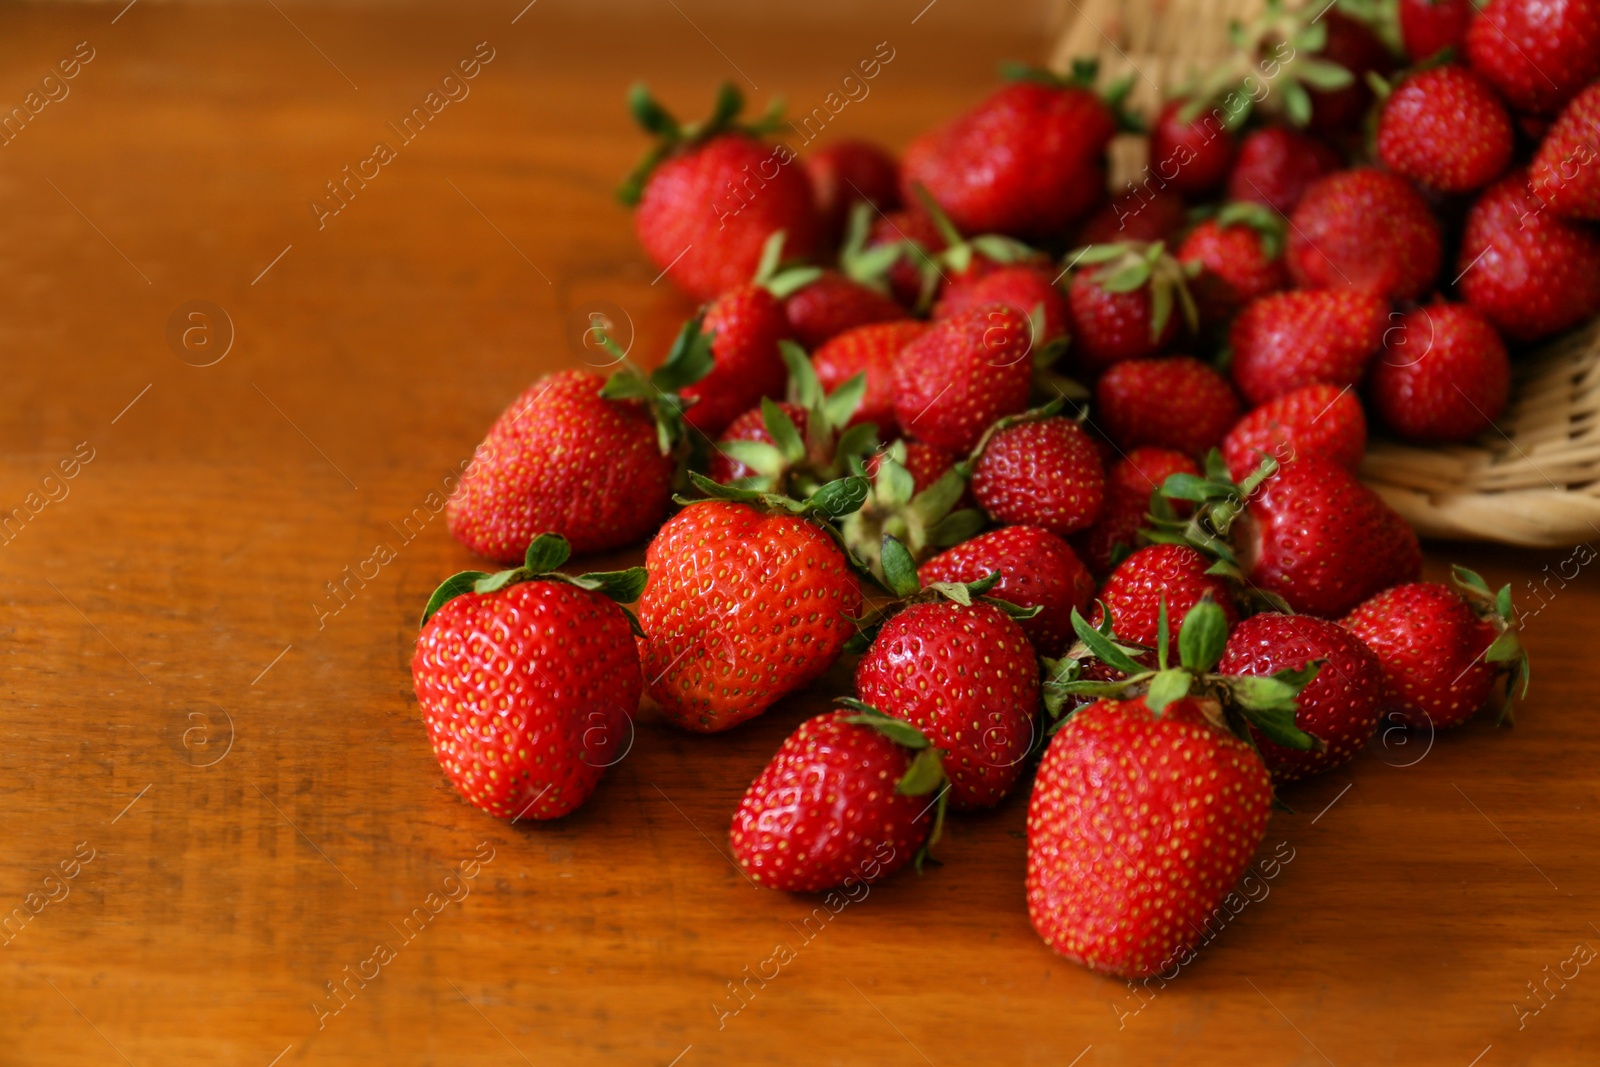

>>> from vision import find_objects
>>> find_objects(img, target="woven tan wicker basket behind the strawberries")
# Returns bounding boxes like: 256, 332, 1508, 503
1053, 0, 1600, 547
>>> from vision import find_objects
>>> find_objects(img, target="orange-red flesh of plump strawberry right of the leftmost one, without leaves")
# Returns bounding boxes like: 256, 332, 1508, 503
638, 501, 861, 733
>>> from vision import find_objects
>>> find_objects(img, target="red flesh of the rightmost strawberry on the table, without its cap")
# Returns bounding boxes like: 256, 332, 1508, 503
1344, 582, 1498, 728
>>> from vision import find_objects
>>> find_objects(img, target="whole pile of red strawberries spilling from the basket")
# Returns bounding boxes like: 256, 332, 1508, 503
411, 0, 1600, 976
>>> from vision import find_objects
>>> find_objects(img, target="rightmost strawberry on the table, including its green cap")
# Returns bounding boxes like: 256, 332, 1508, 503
1344, 566, 1528, 728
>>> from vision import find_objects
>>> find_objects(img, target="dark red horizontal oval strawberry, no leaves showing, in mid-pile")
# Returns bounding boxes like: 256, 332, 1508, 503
1094, 355, 1238, 456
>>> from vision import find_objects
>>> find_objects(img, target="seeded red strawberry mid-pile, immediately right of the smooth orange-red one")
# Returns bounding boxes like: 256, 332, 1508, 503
894, 304, 1034, 453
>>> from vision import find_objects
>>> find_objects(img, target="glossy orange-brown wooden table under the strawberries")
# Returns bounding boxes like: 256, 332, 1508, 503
0, 0, 1600, 1067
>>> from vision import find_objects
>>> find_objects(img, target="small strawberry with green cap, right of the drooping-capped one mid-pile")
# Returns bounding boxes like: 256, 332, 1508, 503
1178, 203, 1290, 330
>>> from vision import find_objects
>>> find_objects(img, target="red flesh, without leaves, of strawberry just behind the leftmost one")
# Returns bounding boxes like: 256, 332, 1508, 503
445, 370, 674, 563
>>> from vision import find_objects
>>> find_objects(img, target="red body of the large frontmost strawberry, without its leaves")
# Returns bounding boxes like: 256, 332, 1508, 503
1027, 697, 1272, 977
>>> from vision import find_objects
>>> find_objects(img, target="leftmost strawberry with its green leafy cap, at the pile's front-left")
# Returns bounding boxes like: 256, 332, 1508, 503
411, 534, 645, 822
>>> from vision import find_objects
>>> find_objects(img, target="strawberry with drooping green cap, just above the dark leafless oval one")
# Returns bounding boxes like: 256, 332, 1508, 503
1067, 243, 1198, 374
